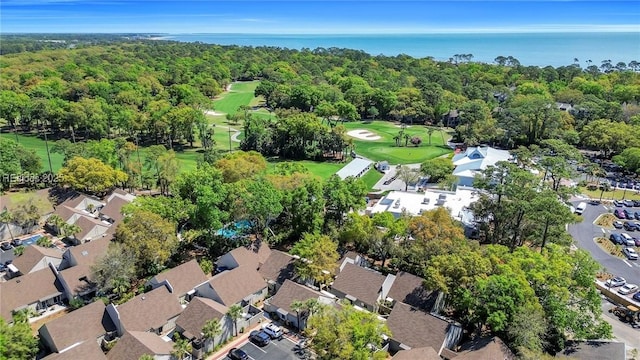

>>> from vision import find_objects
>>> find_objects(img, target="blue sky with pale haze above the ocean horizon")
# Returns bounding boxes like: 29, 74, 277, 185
0, 0, 640, 34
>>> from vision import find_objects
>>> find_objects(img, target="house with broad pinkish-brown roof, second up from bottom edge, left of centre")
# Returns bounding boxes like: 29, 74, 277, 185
107, 286, 183, 336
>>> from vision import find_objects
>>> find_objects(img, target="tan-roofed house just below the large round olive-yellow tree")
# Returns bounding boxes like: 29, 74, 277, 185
147, 259, 208, 302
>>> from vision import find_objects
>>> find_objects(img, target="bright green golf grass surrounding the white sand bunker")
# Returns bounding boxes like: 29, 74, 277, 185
344, 121, 451, 164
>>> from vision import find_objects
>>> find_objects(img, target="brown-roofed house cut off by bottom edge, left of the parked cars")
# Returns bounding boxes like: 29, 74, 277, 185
107, 331, 173, 360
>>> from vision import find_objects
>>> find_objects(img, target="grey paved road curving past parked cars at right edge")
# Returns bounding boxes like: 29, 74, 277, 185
568, 200, 640, 284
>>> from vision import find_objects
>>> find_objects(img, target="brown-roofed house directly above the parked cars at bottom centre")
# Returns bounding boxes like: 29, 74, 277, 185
264, 280, 336, 329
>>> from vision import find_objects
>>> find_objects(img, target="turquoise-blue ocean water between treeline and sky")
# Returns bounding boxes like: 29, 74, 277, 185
162, 32, 640, 67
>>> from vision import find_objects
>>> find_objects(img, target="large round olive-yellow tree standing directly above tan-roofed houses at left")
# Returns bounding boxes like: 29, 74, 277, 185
115, 210, 178, 275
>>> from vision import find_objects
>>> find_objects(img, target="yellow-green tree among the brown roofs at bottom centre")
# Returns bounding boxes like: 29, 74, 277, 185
290, 234, 338, 287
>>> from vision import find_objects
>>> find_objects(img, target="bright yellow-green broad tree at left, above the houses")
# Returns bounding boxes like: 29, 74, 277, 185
58, 157, 127, 194
